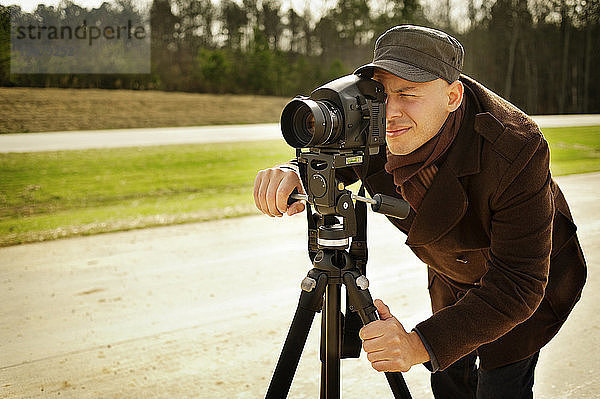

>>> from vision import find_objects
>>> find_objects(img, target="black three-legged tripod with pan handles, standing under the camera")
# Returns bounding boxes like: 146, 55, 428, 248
266, 194, 411, 399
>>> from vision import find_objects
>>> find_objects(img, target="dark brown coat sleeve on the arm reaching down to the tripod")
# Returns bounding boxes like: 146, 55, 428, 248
416, 135, 554, 370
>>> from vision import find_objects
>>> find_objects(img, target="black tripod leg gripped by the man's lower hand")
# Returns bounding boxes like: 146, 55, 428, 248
343, 270, 411, 399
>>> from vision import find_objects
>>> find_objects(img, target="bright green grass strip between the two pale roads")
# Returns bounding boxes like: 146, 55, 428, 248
0, 126, 600, 246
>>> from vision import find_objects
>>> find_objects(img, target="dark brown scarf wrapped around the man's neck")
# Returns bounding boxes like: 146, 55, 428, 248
385, 99, 465, 211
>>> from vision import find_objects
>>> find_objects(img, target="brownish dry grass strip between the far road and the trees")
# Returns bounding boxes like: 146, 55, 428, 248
0, 87, 289, 133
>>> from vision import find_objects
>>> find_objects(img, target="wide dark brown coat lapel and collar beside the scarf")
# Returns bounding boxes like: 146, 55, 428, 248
406, 85, 504, 246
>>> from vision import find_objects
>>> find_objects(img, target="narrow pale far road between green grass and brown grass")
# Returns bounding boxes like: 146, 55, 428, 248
0, 115, 600, 153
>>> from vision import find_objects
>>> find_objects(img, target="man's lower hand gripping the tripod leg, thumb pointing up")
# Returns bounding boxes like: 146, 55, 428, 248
359, 299, 429, 372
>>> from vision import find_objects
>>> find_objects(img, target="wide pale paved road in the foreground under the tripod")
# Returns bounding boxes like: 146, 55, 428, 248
0, 173, 600, 399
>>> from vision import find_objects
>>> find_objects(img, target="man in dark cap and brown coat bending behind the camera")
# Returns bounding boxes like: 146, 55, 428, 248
254, 25, 586, 399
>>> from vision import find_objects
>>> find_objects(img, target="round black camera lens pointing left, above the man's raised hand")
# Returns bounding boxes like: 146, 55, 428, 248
281, 98, 341, 148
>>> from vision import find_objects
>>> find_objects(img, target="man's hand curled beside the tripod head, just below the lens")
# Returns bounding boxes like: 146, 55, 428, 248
254, 167, 304, 217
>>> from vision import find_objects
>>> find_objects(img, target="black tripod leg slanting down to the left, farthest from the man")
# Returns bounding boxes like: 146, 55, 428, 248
265, 269, 327, 399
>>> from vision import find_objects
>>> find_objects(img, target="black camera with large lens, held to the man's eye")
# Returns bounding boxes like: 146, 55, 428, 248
281, 75, 385, 155
